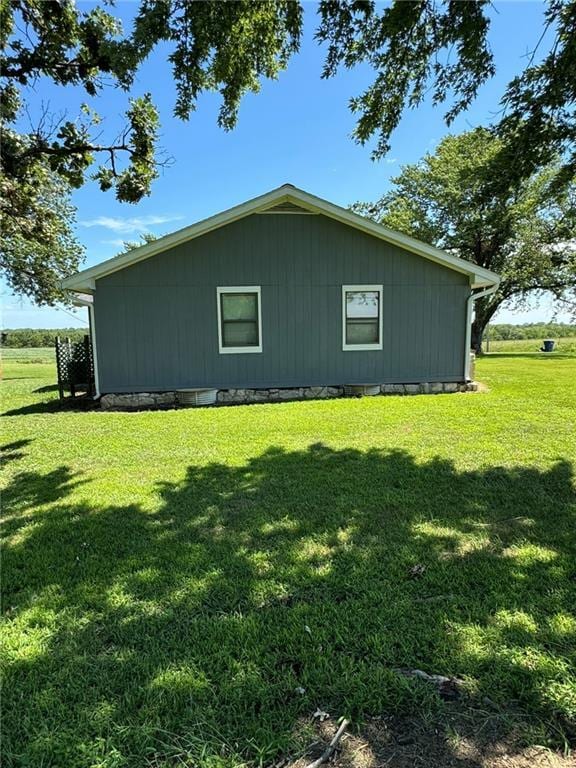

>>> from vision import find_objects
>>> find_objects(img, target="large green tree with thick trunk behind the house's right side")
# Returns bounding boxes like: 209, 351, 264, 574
354, 128, 576, 352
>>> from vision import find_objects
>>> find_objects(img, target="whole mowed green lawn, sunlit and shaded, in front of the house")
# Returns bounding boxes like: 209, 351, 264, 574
2, 355, 576, 768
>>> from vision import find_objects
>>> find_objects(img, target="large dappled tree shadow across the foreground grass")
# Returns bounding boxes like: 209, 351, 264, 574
4, 445, 576, 766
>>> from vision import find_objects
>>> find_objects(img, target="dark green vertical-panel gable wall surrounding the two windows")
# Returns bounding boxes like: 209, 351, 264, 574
94, 214, 470, 393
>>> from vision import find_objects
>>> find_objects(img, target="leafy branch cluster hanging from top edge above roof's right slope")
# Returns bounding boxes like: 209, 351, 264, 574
317, 0, 495, 158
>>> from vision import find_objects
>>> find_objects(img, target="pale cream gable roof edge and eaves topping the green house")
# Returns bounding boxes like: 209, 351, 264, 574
61, 184, 500, 293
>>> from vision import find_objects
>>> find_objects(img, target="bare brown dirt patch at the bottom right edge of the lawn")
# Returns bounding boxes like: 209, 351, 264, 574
293, 704, 576, 768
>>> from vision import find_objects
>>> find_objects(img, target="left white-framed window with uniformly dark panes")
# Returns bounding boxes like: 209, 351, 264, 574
217, 286, 262, 354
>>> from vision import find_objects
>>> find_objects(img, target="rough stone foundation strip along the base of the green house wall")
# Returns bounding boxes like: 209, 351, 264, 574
100, 381, 478, 411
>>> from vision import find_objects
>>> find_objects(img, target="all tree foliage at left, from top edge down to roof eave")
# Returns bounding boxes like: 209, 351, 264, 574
0, 0, 302, 304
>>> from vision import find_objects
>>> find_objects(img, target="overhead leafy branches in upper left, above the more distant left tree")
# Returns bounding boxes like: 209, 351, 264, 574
0, 0, 301, 203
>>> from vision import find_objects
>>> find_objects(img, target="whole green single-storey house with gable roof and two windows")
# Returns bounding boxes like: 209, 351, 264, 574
63, 184, 499, 405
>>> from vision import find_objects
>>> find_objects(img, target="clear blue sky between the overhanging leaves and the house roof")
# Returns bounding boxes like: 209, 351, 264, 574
2, 1, 563, 328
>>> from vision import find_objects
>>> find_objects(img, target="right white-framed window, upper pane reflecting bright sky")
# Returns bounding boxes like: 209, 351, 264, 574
342, 285, 382, 351
